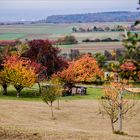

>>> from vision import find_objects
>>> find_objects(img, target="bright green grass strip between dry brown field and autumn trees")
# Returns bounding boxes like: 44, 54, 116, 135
0, 84, 140, 101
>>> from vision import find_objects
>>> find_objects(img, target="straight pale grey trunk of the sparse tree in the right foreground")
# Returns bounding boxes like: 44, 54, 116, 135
118, 92, 122, 132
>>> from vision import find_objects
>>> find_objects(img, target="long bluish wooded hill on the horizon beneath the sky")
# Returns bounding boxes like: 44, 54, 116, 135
38, 11, 140, 23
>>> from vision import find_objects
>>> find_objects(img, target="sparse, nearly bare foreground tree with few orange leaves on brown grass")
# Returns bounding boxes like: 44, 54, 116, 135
101, 82, 136, 133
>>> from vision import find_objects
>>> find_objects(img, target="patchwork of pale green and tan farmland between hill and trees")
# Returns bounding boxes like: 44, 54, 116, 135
0, 22, 131, 53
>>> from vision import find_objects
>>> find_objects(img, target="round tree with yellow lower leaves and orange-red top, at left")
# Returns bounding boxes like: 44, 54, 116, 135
0, 55, 37, 97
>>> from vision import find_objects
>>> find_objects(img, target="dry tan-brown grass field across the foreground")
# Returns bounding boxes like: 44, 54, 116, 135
0, 100, 140, 140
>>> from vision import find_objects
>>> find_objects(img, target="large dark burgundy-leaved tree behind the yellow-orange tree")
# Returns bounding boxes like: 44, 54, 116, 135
24, 40, 67, 77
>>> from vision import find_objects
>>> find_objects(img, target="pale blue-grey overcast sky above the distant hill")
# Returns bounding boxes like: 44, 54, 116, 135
0, 0, 138, 22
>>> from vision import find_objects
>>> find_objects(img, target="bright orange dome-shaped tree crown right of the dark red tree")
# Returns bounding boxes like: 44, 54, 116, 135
58, 54, 103, 83
